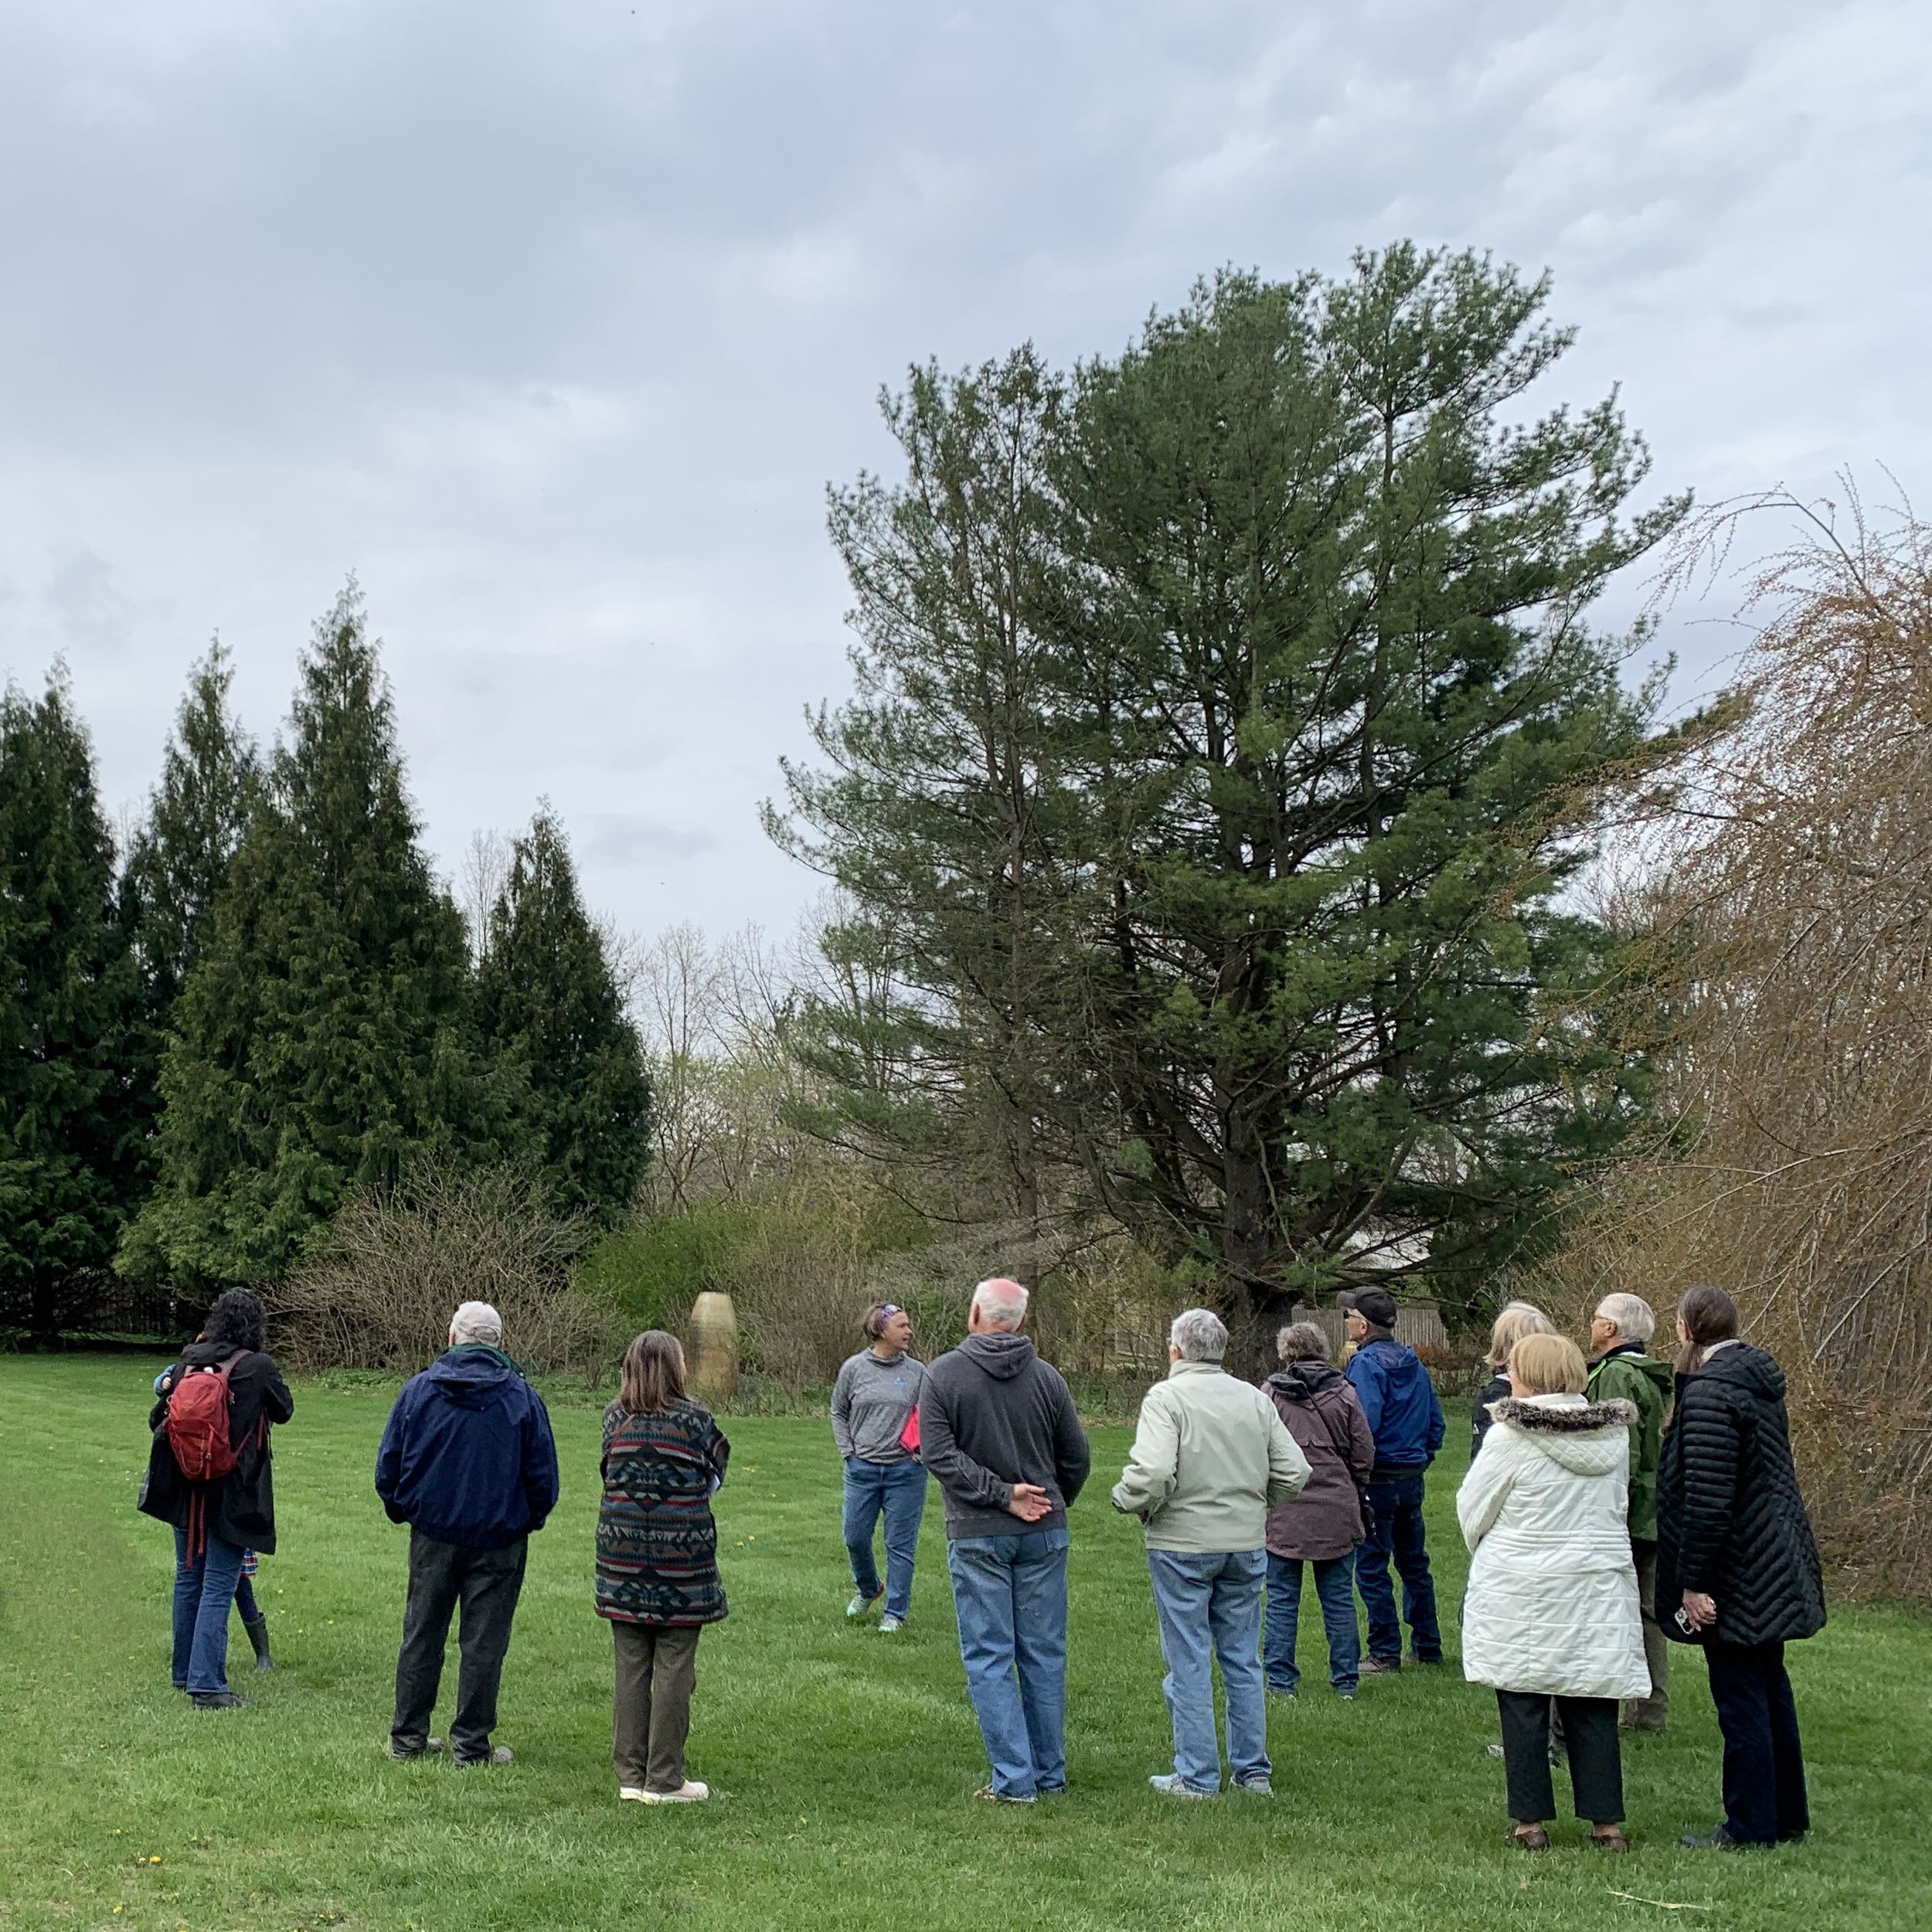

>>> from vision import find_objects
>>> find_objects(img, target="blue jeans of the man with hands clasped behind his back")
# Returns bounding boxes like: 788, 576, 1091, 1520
947, 1530, 1069, 1799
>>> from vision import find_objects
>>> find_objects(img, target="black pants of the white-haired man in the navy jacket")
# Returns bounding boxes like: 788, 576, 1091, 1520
389, 1530, 529, 1764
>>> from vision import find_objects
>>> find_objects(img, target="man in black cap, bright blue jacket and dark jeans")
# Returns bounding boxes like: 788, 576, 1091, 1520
1347, 1289, 1444, 1677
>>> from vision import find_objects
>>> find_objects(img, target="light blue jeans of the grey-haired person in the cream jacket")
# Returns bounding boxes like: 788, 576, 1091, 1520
1148, 1549, 1270, 1791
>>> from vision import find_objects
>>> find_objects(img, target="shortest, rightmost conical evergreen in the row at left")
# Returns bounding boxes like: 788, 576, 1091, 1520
478, 811, 651, 1219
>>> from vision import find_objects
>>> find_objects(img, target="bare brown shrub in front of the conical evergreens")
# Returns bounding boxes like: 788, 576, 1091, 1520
274, 1167, 617, 1382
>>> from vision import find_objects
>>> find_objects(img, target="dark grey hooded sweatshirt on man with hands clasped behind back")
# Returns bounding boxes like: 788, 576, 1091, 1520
920, 1333, 1092, 1536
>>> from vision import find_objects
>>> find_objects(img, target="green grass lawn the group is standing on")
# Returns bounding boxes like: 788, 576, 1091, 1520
0, 1356, 1932, 1932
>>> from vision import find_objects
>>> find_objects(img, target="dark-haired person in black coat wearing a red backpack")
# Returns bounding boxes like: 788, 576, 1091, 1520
141, 1289, 296, 1710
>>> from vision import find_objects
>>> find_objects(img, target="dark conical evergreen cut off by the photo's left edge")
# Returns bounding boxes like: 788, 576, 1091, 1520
0, 675, 143, 1335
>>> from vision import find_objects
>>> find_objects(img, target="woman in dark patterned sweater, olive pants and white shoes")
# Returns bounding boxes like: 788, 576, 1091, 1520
597, 1329, 730, 1804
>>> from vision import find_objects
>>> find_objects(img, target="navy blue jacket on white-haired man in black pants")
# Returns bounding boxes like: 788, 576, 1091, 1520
375, 1349, 556, 1549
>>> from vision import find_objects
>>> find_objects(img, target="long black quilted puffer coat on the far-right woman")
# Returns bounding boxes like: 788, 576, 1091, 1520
1658, 1343, 1824, 1645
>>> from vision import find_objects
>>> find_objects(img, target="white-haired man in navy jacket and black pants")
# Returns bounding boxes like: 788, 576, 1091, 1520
375, 1302, 556, 1768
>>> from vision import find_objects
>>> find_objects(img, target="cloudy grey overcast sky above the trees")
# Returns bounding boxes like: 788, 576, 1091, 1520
0, 0, 1932, 934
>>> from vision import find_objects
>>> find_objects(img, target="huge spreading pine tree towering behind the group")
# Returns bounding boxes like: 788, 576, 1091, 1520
784, 246, 1685, 1360
